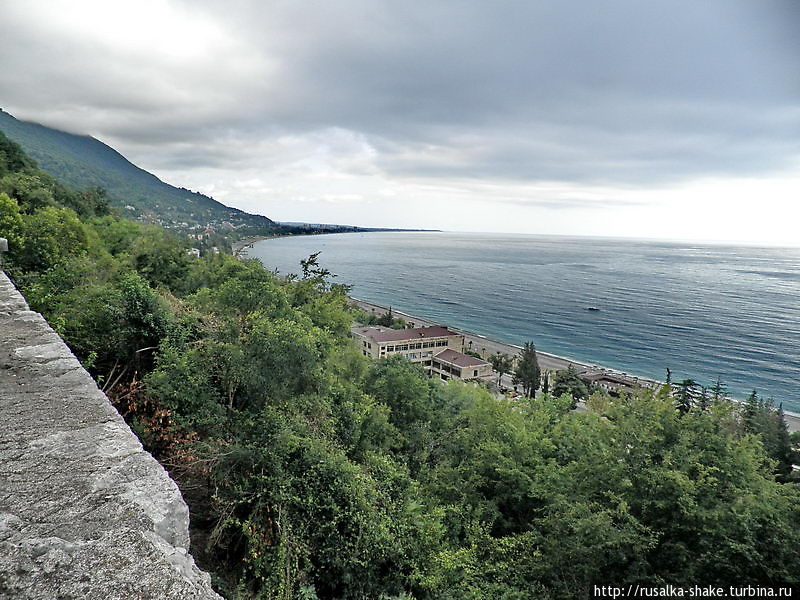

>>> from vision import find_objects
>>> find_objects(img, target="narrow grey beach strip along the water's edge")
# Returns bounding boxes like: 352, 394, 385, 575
351, 297, 800, 432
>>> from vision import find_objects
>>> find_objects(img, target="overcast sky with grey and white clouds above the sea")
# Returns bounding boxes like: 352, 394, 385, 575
0, 0, 800, 245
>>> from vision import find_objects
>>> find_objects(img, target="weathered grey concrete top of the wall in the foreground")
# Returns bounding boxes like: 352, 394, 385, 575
0, 272, 219, 600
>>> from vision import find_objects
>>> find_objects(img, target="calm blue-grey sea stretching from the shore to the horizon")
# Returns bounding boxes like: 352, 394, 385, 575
250, 233, 800, 412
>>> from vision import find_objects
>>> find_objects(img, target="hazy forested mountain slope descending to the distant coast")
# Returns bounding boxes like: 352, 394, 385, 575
0, 109, 278, 230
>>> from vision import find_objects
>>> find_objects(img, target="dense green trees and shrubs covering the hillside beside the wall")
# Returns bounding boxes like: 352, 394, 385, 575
0, 130, 800, 600
